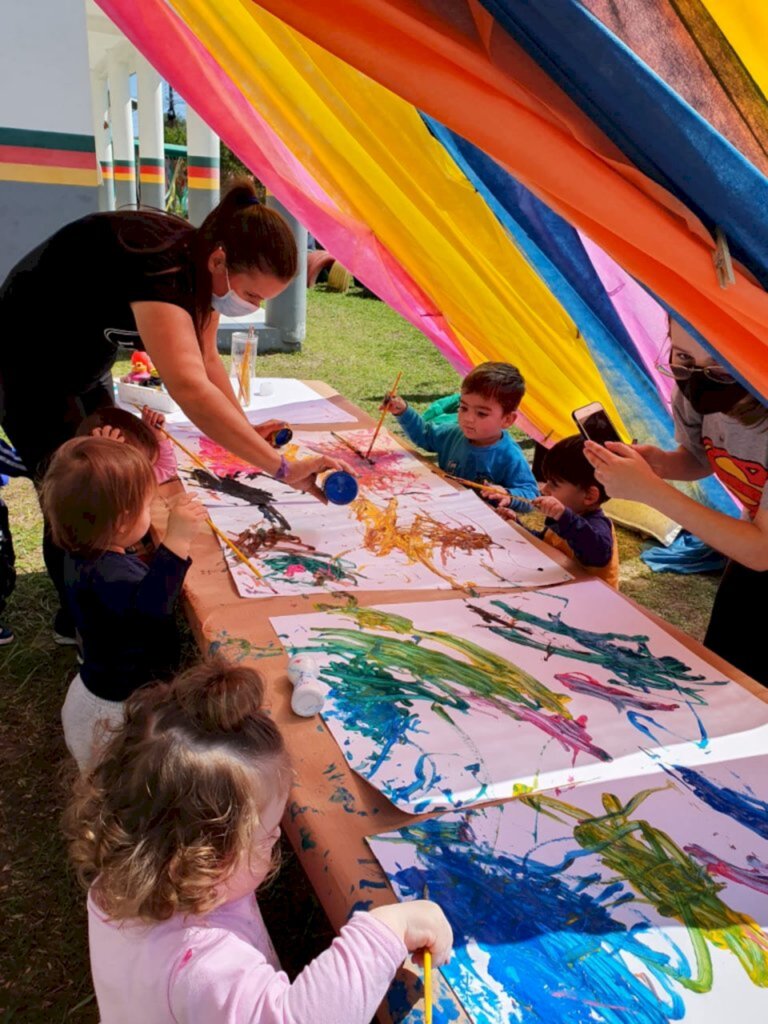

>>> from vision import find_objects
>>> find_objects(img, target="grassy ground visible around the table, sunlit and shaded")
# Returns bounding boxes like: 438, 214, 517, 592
0, 290, 717, 1024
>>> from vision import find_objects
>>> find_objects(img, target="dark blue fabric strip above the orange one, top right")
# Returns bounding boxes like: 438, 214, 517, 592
482, 0, 768, 287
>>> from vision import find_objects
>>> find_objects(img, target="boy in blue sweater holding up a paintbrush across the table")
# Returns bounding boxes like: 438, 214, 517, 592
382, 362, 539, 511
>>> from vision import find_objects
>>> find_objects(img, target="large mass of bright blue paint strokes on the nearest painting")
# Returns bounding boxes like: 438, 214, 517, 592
379, 811, 689, 1024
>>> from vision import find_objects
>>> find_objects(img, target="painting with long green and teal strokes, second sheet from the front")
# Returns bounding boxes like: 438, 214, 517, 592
272, 581, 768, 813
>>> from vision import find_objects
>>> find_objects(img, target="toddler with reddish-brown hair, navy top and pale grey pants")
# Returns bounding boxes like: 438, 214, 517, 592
41, 437, 206, 770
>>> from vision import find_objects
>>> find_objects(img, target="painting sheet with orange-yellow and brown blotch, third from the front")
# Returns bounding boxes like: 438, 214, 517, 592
210, 492, 570, 597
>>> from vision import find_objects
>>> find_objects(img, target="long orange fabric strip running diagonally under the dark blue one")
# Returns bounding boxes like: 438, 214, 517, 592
260, 0, 768, 395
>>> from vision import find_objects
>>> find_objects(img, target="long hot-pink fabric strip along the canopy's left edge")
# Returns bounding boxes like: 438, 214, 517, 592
96, 0, 471, 374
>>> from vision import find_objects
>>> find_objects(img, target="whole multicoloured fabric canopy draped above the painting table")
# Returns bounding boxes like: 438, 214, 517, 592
98, 0, 768, 495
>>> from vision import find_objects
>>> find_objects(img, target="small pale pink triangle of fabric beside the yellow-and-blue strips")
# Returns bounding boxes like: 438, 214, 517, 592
579, 231, 675, 409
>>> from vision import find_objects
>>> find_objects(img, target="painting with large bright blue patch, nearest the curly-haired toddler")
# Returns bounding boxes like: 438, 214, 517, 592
369, 757, 768, 1024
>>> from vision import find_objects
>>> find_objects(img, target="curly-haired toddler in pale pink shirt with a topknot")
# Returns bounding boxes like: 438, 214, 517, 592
66, 659, 453, 1024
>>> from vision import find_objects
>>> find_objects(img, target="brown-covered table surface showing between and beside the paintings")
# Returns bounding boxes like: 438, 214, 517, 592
168, 381, 768, 1024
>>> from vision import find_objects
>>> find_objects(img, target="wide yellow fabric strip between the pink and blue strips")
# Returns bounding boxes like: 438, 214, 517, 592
171, 0, 622, 438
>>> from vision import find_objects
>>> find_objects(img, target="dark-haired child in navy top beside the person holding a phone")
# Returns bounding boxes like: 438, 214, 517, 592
500, 434, 618, 589
